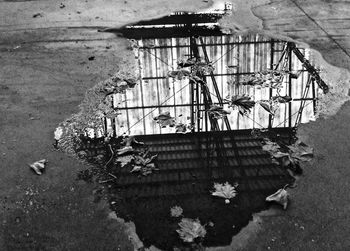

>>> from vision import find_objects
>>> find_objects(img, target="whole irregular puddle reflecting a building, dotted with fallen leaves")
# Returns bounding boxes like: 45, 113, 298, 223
55, 10, 328, 250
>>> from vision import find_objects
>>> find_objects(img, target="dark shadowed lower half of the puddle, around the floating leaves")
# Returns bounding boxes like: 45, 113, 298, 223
76, 128, 294, 250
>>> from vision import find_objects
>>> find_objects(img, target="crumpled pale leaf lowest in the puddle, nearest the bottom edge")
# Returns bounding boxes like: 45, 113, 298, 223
176, 218, 207, 242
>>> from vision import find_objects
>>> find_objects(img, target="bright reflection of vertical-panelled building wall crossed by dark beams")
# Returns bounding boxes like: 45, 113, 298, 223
107, 14, 326, 135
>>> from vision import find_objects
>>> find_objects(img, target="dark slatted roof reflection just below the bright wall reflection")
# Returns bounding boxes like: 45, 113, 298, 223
113, 129, 290, 198
